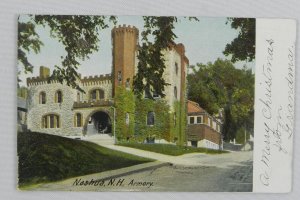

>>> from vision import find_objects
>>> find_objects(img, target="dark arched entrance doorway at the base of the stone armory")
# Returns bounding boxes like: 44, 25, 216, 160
87, 111, 112, 135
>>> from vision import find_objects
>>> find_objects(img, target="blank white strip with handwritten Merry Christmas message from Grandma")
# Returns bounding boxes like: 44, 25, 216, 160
253, 19, 296, 193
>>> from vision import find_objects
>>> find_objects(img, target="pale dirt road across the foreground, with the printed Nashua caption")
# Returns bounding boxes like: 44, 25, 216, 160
29, 152, 253, 192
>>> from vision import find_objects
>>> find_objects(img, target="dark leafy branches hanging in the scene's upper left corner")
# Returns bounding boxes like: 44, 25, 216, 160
18, 15, 116, 89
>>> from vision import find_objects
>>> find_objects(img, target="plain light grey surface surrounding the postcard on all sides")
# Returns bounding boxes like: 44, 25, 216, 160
0, 0, 300, 200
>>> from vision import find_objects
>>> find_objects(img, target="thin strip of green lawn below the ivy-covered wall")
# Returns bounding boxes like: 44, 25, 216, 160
118, 142, 228, 156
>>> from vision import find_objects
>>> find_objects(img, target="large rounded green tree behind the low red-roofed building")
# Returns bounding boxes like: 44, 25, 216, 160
188, 59, 254, 140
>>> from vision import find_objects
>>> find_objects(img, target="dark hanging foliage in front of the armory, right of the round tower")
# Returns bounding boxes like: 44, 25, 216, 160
133, 16, 198, 98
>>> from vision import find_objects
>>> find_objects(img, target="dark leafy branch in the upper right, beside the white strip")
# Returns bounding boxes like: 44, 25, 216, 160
223, 18, 256, 62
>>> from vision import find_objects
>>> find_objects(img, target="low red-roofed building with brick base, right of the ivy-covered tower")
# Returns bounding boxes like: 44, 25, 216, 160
187, 101, 223, 149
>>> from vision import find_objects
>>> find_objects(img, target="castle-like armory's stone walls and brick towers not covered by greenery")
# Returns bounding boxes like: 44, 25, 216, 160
27, 26, 188, 140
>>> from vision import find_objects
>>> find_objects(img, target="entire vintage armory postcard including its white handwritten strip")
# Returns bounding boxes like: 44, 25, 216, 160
17, 15, 296, 193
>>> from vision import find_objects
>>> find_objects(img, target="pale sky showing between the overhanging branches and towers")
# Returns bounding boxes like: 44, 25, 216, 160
18, 16, 255, 85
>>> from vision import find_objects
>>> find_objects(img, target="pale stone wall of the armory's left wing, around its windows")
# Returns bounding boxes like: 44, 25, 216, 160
27, 81, 112, 136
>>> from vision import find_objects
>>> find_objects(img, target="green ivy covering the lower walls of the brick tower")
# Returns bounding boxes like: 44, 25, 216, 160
115, 86, 186, 145
